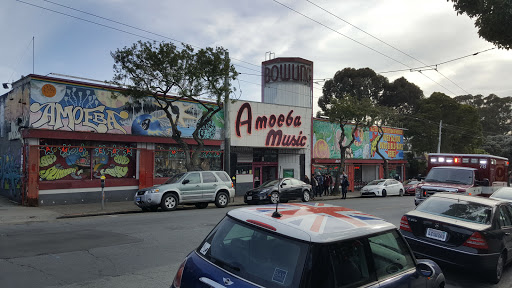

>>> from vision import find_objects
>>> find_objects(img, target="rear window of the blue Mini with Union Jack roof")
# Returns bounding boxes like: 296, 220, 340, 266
196, 216, 309, 287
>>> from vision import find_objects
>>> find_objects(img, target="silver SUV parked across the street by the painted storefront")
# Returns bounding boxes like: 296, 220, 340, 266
133, 171, 235, 211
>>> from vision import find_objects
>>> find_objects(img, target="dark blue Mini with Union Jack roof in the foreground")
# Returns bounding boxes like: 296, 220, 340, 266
171, 203, 445, 288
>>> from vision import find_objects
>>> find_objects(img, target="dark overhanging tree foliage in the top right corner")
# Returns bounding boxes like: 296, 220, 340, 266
449, 0, 512, 50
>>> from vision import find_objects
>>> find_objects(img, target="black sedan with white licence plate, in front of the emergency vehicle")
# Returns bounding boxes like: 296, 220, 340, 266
400, 193, 512, 283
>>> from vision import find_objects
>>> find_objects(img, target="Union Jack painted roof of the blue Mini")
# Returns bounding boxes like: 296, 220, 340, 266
228, 203, 396, 243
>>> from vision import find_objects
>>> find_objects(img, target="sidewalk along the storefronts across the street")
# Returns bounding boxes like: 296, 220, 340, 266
0, 191, 360, 224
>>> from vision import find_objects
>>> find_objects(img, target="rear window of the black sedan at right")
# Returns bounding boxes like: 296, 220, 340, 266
416, 197, 492, 224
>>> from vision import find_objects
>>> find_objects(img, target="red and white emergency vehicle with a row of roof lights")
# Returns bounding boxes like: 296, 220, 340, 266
414, 153, 509, 205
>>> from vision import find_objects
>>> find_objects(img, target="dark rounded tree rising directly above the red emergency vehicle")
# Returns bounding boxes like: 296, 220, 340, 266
405, 92, 482, 154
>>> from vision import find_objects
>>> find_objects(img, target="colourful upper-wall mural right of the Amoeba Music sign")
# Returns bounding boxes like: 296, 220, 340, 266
313, 120, 404, 160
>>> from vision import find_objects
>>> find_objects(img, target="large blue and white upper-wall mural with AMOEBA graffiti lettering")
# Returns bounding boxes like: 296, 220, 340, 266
30, 80, 224, 140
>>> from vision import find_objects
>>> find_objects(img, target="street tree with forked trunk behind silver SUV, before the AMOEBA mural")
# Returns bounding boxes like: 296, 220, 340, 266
111, 41, 238, 171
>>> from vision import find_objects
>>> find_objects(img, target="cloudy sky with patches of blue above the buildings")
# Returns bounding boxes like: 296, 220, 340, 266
0, 0, 512, 112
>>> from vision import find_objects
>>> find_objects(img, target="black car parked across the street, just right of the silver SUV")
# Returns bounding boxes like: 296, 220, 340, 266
244, 178, 312, 204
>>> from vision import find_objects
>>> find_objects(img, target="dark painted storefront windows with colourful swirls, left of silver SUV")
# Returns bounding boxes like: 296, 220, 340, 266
39, 143, 135, 181
